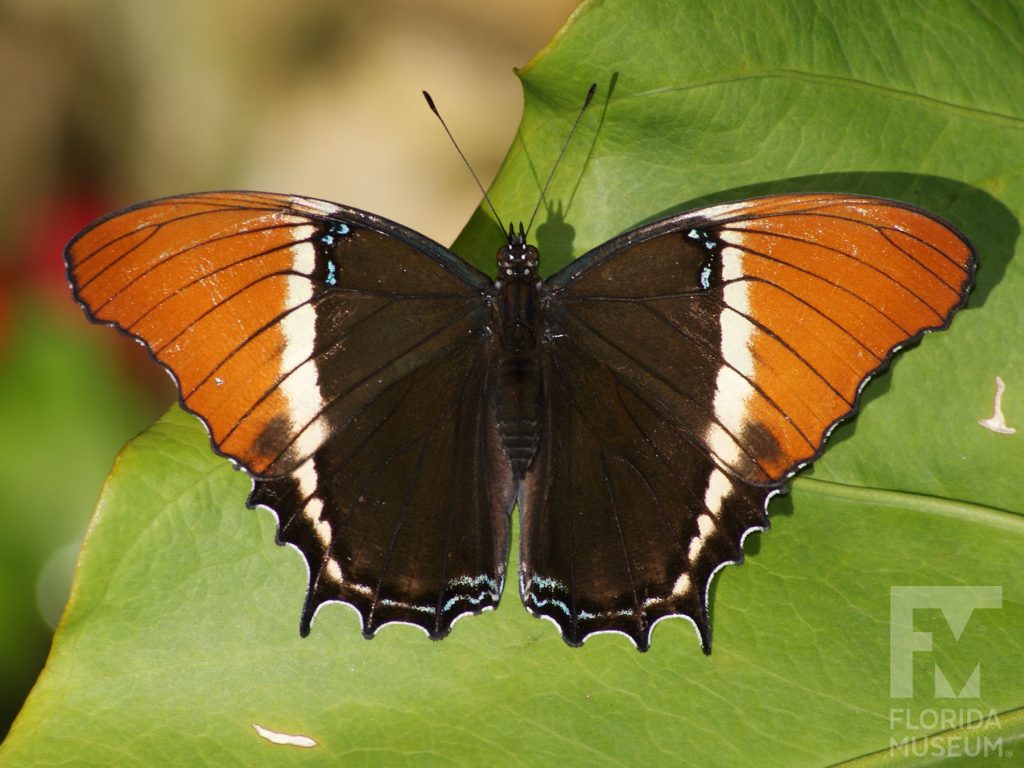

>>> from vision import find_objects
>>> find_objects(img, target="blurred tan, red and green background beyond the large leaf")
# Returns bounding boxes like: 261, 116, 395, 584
0, 0, 577, 738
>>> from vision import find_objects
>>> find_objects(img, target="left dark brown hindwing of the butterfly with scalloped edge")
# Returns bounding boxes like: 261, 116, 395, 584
250, 335, 512, 638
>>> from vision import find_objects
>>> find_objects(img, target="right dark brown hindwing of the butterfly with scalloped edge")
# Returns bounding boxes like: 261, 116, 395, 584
520, 334, 774, 650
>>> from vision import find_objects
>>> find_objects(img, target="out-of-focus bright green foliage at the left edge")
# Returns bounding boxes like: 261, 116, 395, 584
0, 296, 157, 733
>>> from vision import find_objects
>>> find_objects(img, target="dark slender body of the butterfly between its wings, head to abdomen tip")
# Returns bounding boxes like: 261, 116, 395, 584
493, 237, 543, 478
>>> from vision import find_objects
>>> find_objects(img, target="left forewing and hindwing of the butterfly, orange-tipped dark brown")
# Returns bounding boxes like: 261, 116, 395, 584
66, 193, 512, 638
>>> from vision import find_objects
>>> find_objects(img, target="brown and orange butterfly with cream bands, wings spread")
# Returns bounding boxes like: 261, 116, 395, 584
66, 100, 977, 652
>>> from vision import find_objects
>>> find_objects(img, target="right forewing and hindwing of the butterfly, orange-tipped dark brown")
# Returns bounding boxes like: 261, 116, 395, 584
520, 195, 975, 651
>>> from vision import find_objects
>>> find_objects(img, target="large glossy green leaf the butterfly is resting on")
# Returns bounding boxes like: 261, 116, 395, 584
0, 0, 1024, 766
